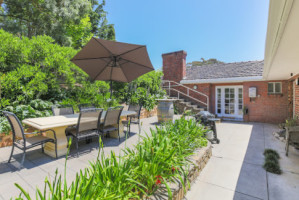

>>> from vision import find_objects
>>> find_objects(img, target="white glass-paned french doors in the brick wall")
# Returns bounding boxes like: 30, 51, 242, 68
215, 86, 243, 118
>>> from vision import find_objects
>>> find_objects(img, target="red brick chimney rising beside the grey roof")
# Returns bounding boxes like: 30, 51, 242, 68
162, 50, 187, 83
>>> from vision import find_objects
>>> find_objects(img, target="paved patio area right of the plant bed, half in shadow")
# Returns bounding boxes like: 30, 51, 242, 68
186, 122, 299, 200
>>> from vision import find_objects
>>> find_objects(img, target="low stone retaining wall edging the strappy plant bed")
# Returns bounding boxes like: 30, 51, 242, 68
145, 142, 212, 200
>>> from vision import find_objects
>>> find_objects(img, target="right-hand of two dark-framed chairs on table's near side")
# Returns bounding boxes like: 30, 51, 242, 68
100, 106, 124, 142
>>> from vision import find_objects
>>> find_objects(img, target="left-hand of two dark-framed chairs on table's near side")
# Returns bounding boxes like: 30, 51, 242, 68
67, 108, 103, 156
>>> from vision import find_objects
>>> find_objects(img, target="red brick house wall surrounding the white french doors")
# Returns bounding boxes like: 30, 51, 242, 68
186, 81, 290, 123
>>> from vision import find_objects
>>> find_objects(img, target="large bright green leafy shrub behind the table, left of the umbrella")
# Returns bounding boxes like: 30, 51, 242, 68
0, 29, 115, 109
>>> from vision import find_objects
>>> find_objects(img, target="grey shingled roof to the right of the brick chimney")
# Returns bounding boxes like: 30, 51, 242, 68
185, 60, 264, 80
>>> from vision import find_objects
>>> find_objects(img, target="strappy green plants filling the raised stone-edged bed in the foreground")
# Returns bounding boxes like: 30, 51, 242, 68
16, 118, 207, 200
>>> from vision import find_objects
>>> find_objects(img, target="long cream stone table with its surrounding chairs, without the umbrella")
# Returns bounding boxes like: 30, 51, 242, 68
3, 104, 142, 166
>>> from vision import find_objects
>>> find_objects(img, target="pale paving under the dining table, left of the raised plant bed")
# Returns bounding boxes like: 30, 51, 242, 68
0, 116, 162, 200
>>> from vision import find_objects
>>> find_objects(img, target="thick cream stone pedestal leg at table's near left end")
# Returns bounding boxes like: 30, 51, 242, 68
44, 126, 67, 158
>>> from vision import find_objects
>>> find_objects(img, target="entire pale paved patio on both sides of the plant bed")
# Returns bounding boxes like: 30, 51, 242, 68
0, 117, 299, 200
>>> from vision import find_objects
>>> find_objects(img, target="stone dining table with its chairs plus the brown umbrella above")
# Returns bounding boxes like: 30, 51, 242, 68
3, 37, 154, 165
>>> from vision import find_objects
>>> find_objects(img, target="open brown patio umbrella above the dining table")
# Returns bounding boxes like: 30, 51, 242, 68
71, 37, 154, 95
